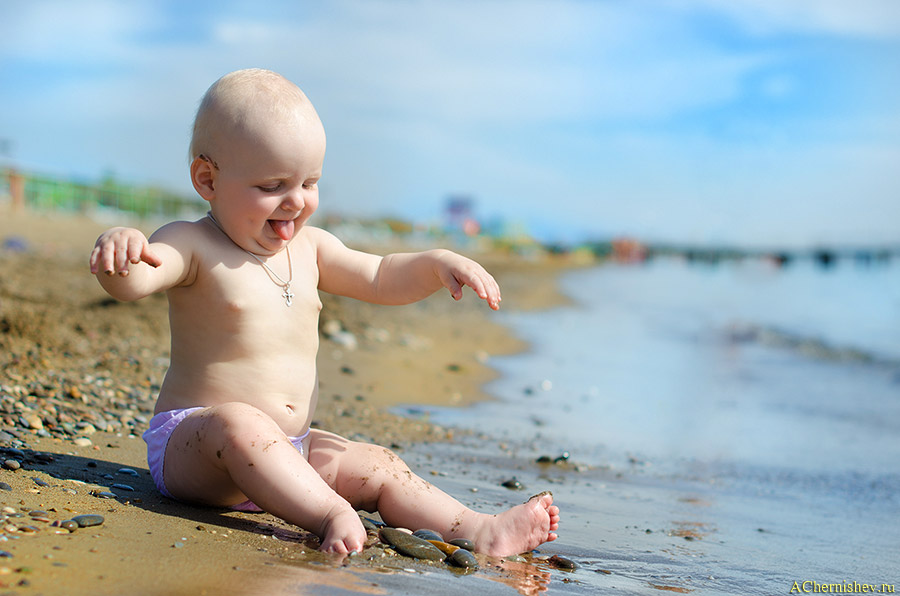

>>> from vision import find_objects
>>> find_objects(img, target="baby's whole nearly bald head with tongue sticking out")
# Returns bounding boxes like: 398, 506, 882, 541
191, 69, 325, 254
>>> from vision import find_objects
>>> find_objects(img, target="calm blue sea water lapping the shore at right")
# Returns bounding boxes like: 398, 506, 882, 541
399, 258, 900, 594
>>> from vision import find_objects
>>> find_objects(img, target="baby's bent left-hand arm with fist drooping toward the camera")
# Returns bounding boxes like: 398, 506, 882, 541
90, 222, 190, 300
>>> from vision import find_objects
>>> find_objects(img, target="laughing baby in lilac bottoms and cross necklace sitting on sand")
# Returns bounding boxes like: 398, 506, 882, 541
90, 69, 559, 556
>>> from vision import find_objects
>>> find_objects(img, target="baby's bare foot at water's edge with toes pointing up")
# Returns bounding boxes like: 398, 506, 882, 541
474, 492, 559, 557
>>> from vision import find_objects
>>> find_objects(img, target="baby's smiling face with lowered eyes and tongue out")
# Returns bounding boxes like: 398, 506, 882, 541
206, 109, 325, 255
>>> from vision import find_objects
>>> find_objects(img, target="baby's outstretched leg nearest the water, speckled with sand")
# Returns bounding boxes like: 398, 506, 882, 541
309, 430, 559, 556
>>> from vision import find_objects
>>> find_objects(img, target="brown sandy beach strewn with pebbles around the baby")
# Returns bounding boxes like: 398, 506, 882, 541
0, 207, 576, 595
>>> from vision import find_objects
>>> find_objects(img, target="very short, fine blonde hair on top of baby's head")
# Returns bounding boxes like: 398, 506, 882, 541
189, 68, 318, 161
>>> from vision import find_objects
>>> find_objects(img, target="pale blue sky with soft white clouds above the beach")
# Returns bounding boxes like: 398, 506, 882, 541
0, 0, 900, 247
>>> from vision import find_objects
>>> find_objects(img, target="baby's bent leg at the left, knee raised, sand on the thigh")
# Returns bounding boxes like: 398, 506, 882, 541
164, 403, 366, 553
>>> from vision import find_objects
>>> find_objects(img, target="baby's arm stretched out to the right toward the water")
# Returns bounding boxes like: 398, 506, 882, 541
308, 228, 501, 310
